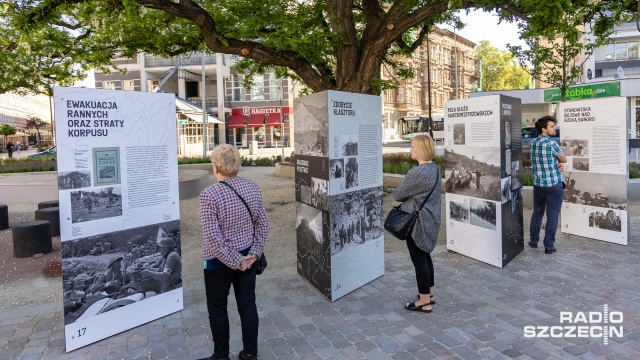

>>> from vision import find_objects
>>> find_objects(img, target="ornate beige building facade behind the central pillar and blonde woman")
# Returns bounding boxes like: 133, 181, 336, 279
382, 27, 479, 140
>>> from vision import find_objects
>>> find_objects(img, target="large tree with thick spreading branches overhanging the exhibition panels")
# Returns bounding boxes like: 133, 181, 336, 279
6, 0, 637, 94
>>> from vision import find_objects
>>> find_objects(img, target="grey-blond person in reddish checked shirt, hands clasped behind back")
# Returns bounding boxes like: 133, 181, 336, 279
199, 144, 269, 360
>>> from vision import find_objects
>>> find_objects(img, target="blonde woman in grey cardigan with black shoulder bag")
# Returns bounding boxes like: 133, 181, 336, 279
393, 135, 442, 313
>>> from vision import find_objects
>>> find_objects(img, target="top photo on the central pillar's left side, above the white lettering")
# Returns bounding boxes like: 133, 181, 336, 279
294, 98, 329, 157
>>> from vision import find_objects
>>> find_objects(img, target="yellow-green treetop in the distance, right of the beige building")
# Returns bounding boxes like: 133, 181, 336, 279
475, 40, 529, 91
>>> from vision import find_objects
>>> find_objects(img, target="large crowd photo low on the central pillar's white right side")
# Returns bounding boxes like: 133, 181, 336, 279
329, 187, 384, 255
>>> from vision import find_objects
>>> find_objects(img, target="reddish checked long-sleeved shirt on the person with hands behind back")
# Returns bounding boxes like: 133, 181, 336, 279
198, 177, 269, 269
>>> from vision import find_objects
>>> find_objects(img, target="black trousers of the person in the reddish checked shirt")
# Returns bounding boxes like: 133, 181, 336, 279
204, 267, 259, 359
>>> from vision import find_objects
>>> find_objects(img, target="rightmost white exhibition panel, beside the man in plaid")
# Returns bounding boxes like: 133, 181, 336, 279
558, 97, 629, 245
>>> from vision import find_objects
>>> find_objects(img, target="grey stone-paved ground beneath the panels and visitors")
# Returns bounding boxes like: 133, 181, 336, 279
0, 226, 640, 360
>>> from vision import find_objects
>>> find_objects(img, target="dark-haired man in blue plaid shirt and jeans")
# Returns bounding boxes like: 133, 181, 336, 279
529, 115, 567, 254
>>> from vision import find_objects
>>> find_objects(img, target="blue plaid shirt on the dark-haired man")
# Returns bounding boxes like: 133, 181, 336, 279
531, 135, 562, 187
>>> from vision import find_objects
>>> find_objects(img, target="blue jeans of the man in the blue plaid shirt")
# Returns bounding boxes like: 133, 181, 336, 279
529, 182, 564, 249
